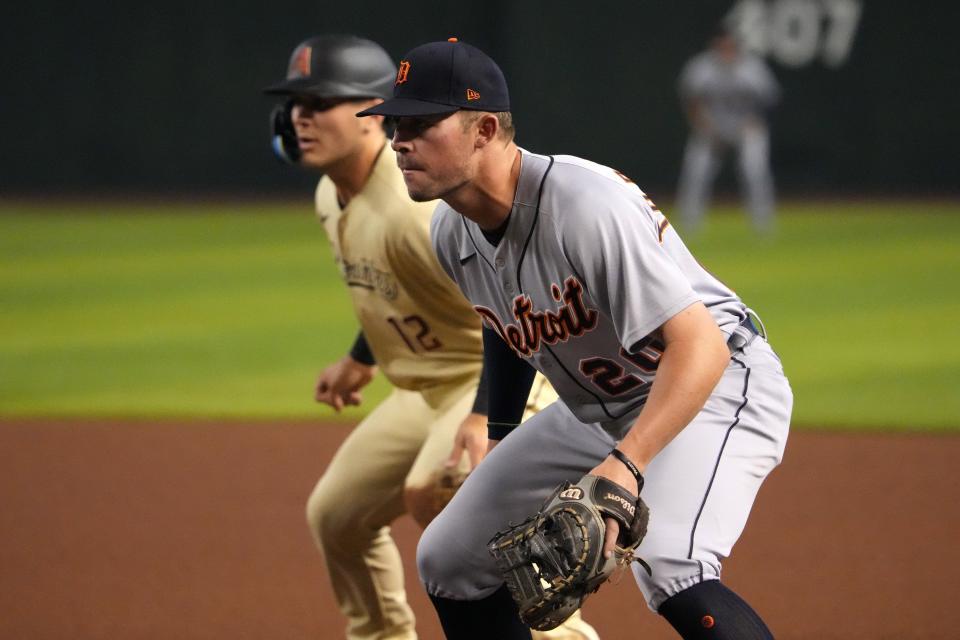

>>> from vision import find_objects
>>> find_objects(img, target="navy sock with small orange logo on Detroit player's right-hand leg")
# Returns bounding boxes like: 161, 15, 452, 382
658, 580, 773, 640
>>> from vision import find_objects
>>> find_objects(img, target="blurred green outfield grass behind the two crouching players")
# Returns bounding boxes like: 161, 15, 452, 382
0, 199, 960, 429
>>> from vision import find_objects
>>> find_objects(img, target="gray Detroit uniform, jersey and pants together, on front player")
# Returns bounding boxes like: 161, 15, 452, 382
417, 152, 792, 611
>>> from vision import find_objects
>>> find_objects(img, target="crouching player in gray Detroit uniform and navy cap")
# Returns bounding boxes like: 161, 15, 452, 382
359, 41, 792, 640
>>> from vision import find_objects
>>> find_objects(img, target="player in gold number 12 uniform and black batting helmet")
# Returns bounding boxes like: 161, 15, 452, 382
265, 35, 597, 640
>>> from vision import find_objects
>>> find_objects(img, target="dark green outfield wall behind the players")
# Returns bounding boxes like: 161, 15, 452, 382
0, 0, 960, 195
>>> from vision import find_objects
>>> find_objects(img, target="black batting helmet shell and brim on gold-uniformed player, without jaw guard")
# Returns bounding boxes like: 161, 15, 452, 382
263, 35, 397, 99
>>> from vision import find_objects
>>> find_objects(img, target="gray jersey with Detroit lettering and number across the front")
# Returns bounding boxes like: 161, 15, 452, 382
431, 151, 746, 425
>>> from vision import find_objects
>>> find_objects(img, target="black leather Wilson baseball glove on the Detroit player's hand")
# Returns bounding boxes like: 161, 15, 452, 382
487, 475, 650, 631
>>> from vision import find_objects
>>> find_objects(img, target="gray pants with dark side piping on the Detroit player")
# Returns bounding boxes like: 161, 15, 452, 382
417, 337, 793, 611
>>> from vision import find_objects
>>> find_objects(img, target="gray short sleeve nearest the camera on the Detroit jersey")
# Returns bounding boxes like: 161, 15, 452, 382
559, 178, 700, 350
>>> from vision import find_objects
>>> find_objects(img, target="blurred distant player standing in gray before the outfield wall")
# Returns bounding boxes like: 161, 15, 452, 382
678, 29, 780, 232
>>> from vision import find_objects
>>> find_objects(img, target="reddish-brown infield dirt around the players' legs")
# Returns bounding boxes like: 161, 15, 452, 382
0, 420, 960, 640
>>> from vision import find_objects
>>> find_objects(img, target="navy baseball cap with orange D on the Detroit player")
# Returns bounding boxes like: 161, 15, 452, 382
357, 38, 510, 116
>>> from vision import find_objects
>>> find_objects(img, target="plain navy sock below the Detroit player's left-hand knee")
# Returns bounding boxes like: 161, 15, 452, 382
430, 585, 530, 640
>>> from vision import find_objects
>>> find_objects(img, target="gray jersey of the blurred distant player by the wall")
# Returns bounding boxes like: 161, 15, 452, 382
680, 51, 780, 142
